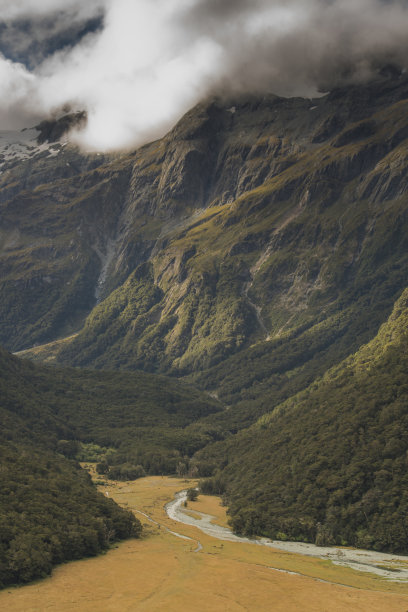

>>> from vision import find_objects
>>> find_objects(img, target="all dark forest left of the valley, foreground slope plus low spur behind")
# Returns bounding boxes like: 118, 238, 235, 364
0, 349, 220, 586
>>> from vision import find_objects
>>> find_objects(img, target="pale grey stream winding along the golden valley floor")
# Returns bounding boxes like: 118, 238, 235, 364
165, 491, 408, 582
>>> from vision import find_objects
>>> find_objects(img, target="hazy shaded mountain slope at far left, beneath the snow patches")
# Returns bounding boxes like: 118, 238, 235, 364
0, 144, 131, 349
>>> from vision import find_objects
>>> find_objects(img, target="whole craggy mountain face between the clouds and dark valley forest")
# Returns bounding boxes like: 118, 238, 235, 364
0, 71, 408, 386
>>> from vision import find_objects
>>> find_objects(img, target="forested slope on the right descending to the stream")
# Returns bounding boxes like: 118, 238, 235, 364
195, 290, 408, 553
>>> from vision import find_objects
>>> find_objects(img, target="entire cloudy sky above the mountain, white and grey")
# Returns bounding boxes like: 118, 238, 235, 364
0, 0, 408, 151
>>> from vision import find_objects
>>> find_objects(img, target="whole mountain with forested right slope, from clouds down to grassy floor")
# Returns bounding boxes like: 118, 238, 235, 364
0, 73, 408, 551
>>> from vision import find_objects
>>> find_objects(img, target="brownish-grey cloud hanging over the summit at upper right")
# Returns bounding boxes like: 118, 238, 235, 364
184, 0, 408, 95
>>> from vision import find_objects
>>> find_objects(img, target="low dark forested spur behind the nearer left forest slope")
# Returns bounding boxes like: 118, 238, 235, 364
0, 344, 222, 473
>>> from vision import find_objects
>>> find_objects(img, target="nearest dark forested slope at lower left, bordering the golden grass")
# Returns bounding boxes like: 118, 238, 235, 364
0, 443, 141, 587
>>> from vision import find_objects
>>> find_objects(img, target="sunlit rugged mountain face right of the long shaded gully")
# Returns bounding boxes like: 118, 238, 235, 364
52, 71, 408, 392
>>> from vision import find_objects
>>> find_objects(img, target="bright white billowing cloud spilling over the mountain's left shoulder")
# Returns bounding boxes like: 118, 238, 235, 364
32, 0, 222, 149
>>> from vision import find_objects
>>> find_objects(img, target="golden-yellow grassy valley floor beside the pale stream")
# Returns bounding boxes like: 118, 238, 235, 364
0, 477, 408, 612
